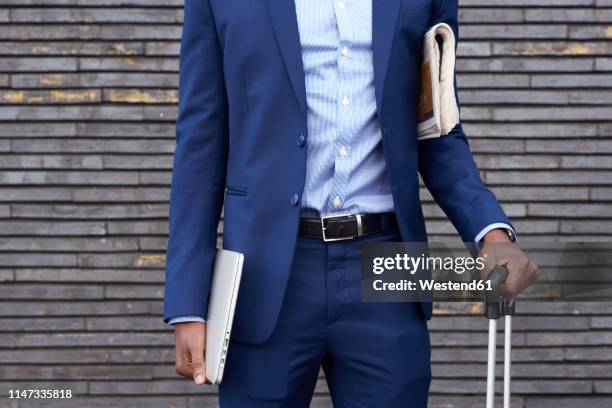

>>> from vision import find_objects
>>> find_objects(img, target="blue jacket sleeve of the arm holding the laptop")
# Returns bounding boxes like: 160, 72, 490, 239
164, 0, 228, 322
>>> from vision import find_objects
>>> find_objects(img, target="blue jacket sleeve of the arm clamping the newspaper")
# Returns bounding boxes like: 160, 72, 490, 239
419, 0, 511, 242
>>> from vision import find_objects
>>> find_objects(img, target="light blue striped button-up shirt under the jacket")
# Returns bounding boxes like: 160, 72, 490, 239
295, 0, 393, 216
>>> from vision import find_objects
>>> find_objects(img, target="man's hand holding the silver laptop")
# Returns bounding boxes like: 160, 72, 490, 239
174, 322, 207, 384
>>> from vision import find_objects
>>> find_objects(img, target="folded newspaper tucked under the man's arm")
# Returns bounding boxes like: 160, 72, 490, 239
417, 23, 459, 140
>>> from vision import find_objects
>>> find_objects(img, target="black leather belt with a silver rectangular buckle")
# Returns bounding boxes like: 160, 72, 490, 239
300, 213, 397, 242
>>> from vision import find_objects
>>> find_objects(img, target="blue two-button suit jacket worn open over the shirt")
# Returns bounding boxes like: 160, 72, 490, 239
164, 0, 509, 344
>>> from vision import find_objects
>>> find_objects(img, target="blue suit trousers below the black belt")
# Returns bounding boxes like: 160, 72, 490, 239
219, 231, 431, 408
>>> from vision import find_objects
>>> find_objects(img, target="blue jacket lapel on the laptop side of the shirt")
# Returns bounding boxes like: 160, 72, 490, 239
267, 0, 307, 117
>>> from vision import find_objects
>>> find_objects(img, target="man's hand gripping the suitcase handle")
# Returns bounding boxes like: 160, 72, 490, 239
478, 229, 538, 298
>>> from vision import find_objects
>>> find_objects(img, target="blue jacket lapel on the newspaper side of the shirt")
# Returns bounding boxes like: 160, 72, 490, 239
372, 0, 400, 113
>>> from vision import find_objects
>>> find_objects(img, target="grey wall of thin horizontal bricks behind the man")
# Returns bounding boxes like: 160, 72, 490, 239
0, 0, 612, 408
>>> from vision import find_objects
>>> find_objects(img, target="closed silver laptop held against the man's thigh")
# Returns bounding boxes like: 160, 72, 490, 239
205, 249, 244, 384
